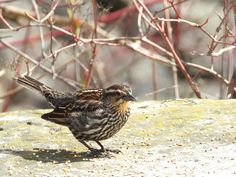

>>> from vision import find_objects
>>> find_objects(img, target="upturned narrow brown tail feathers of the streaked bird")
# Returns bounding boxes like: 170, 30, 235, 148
17, 76, 44, 92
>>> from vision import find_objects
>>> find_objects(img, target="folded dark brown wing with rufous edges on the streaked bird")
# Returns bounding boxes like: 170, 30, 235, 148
42, 100, 105, 130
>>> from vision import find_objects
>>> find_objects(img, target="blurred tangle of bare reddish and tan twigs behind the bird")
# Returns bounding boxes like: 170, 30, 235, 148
0, 0, 236, 112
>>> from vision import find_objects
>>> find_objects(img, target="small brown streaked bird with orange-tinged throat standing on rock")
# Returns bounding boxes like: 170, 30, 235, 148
17, 76, 135, 152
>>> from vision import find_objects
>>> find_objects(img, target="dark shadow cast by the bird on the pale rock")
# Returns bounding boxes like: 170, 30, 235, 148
0, 148, 107, 163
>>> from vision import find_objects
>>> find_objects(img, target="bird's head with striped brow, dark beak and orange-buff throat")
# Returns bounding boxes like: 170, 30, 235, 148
102, 84, 136, 112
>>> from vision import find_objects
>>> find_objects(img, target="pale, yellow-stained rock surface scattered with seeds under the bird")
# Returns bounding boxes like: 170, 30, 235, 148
0, 99, 236, 177
